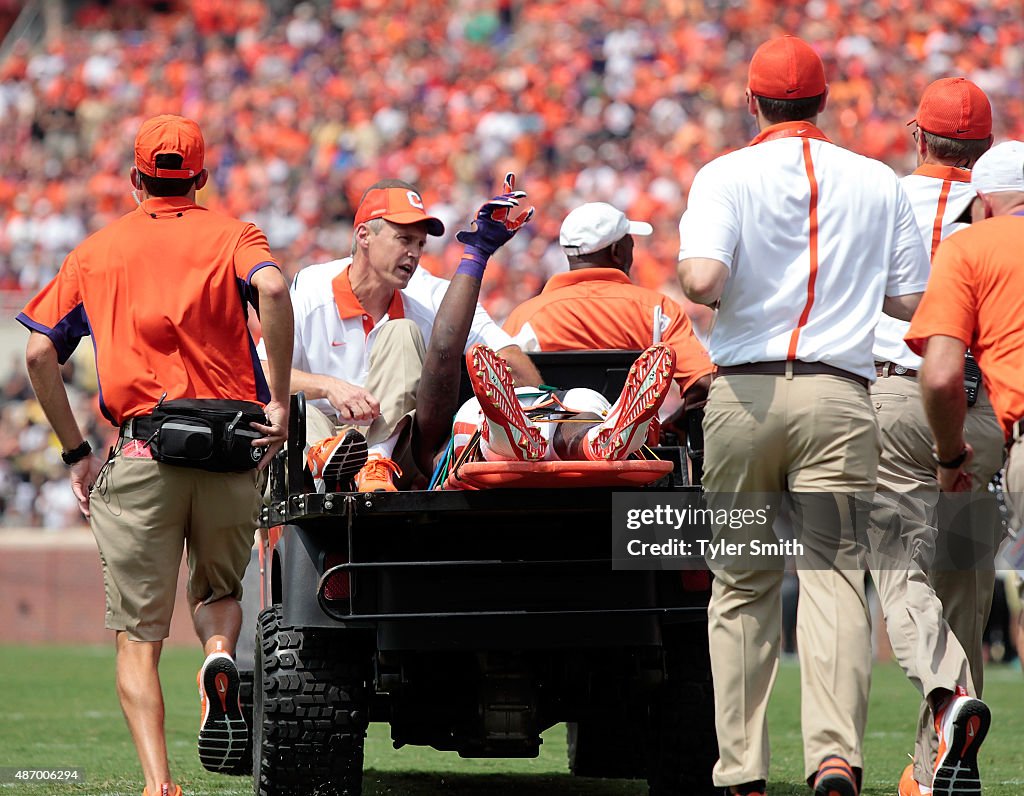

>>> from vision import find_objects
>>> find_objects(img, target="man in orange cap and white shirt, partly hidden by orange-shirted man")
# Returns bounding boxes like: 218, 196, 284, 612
869, 78, 1004, 796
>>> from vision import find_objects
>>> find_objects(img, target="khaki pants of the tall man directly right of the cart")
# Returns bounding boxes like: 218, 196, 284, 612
703, 375, 879, 786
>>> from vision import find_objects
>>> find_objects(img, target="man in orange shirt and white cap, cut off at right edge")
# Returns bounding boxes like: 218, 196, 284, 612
906, 141, 1024, 793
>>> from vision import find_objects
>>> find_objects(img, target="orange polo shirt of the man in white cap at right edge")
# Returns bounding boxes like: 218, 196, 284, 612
906, 215, 1024, 436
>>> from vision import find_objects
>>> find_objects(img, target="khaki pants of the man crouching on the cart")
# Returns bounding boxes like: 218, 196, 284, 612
306, 319, 427, 488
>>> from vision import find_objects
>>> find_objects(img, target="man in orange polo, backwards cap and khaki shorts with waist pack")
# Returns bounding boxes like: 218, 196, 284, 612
17, 116, 292, 796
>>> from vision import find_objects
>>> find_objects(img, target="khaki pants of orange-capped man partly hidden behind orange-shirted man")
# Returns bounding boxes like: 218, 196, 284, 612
869, 375, 1002, 783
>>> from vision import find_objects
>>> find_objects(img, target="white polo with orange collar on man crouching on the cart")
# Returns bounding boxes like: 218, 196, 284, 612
257, 257, 512, 417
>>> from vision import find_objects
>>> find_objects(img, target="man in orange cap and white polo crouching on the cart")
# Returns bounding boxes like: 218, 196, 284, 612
260, 179, 541, 492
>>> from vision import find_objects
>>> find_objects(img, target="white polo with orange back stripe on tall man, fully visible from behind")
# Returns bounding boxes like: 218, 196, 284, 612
679, 122, 928, 381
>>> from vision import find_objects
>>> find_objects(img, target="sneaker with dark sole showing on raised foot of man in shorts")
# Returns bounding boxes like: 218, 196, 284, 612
196, 653, 249, 773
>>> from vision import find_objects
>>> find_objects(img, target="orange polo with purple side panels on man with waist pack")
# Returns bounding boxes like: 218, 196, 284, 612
17, 197, 276, 425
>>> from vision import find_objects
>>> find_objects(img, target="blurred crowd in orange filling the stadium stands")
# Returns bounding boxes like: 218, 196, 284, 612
0, 0, 1024, 522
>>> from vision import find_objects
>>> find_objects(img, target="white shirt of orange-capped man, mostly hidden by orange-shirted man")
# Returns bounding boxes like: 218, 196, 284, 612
874, 163, 977, 370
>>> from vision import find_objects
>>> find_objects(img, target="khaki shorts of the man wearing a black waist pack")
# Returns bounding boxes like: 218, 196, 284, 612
89, 453, 262, 641
